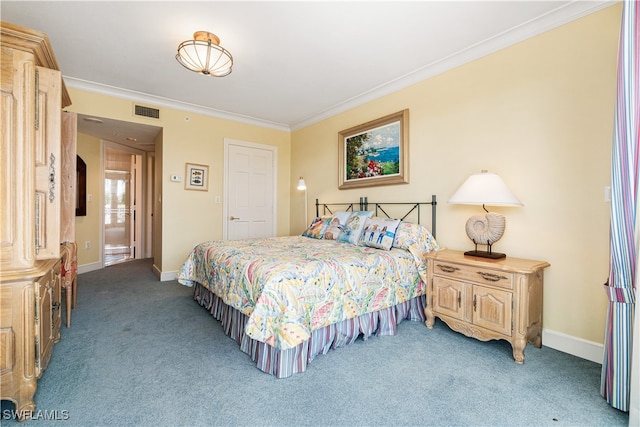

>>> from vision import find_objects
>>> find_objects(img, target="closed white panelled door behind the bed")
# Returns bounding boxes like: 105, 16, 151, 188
223, 139, 277, 240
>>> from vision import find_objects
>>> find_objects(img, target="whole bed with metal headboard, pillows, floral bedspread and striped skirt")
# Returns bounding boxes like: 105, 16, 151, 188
178, 196, 438, 378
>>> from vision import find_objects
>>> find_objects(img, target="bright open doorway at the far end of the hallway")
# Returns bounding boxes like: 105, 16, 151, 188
103, 144, 143, 266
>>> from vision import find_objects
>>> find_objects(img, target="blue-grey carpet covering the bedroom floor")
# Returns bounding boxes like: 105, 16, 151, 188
2, 260, 628, 426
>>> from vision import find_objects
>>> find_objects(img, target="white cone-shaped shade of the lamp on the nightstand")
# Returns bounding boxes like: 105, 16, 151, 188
448, 171, 524, 206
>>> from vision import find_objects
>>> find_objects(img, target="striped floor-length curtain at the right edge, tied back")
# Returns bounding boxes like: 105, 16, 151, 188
600, 0, 640, 411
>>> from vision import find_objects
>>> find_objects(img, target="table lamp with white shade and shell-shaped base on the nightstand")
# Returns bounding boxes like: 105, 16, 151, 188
448, 170, 524, 259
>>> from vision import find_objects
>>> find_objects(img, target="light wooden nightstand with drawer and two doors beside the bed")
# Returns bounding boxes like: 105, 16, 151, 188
425, 249, 549, 363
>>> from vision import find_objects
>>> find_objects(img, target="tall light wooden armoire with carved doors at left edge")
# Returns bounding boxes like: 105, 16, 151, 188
0, 22, 75, 419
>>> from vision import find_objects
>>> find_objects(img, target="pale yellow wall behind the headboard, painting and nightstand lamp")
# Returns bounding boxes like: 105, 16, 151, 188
291, 5, 621, 343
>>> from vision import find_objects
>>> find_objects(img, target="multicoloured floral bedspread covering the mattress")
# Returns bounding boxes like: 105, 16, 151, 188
178, 236, 426, 350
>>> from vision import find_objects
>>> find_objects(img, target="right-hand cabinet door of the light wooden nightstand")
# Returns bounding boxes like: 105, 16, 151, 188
473, 286, 513, 336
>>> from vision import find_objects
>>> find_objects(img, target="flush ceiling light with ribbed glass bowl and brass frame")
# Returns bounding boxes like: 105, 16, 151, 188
176, 31, 233, 77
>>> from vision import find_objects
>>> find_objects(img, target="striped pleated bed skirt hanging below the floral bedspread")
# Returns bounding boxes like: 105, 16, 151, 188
193, 283, 426, 378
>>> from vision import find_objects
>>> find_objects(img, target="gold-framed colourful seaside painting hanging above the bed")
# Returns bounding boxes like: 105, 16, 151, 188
338, 110, 409, 190
